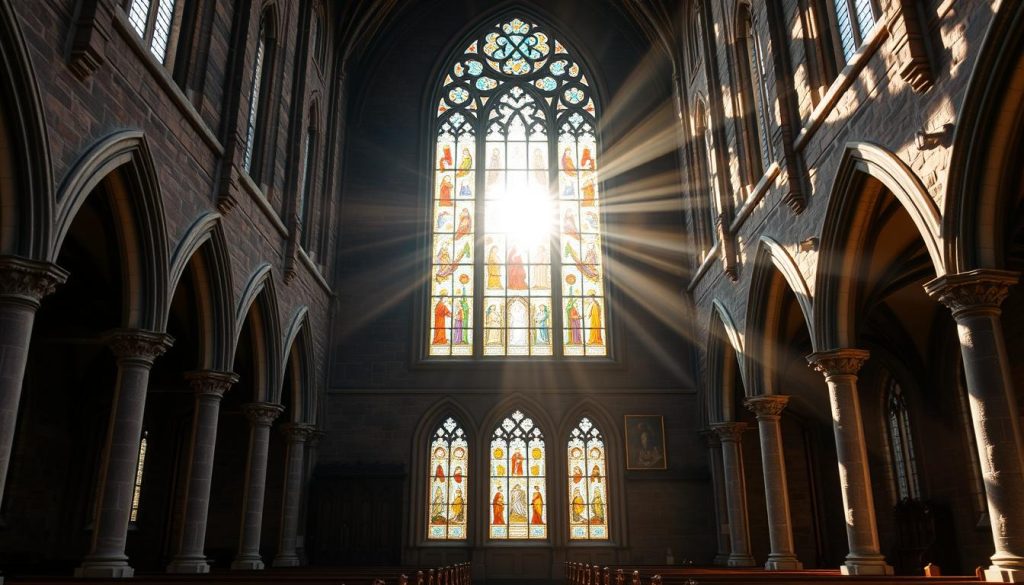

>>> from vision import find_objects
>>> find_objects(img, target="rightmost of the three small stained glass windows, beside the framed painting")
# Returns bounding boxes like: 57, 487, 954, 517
567, 417, 608, 540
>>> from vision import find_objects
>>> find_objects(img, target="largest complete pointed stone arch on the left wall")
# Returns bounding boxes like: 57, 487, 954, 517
48, 130, 170, 331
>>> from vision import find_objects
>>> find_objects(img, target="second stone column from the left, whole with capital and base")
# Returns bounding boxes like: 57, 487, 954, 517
75, 329, 173, 578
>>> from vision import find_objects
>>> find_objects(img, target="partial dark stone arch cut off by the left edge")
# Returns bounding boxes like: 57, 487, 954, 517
0, 0, 53, 259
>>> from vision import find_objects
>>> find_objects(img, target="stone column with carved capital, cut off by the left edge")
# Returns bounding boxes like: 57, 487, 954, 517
0, 256, 68, 503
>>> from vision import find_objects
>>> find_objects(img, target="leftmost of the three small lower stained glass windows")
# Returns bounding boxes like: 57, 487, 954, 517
427, 418, 469, 540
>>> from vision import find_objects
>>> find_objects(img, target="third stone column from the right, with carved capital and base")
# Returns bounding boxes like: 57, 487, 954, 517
745, 394, 804, 571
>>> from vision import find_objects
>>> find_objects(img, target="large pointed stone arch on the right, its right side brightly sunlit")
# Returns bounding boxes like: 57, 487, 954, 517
812, 142, 945, 350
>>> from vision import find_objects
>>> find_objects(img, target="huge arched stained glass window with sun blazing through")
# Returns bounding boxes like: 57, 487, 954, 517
427, 17, 608, 357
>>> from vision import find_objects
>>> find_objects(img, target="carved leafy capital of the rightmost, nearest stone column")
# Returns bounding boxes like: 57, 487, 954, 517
925, 268, 1020, 319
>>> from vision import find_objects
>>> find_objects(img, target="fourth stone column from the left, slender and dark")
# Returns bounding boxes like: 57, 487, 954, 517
231, 403, 285, 571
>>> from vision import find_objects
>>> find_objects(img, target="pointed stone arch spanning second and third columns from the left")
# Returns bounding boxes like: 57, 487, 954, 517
168, 212, 234, 372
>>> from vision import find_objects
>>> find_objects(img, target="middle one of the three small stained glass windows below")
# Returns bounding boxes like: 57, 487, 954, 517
487, 411, 548, 540
